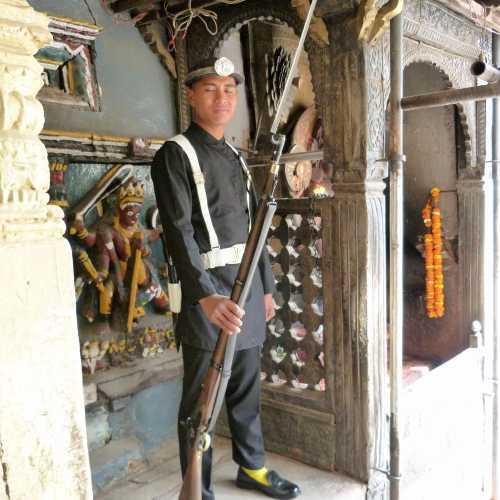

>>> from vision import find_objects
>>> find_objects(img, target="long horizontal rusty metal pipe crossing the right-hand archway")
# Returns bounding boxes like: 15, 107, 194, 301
401, 81, 500, 111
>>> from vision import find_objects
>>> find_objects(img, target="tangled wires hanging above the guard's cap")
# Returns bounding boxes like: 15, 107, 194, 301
164, 0, 245, 50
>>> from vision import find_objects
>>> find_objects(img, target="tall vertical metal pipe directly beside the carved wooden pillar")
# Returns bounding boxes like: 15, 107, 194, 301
389, 9, 405, 500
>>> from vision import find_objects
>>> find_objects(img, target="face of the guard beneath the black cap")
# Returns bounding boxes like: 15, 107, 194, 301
187, 76, 238, 126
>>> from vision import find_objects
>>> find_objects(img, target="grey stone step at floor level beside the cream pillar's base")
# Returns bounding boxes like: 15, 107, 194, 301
90, 437, 147, 493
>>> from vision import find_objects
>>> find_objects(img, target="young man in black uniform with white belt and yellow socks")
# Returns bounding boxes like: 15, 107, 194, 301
151, 58, 300, 500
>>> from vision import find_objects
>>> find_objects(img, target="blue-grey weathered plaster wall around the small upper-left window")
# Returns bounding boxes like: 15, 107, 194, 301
29, 0, 176, 137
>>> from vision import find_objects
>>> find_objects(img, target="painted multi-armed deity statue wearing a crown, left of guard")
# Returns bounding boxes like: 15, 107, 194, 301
72, 178, 168, 330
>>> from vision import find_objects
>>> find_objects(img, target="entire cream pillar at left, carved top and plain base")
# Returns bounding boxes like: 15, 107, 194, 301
0, 0, 92, 500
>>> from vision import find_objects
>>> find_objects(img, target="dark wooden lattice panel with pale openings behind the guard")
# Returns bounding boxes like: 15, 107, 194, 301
262, 201, 325, 392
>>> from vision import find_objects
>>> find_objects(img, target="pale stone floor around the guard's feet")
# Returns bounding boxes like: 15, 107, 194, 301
94, 438, 365, 500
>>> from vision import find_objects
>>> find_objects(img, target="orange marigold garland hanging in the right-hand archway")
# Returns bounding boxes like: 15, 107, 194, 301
422, 188, 444, 318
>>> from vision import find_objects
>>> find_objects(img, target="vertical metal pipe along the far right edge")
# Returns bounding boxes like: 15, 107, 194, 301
492, 35, 500, 500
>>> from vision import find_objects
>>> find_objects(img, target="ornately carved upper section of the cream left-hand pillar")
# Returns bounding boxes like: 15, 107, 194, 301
0, 0, 64, 240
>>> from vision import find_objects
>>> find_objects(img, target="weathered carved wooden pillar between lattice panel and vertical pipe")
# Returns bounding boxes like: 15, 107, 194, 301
322, 19, 389, 500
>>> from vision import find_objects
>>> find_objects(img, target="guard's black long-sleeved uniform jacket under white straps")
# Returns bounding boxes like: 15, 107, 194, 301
151, 123, 275, 351
